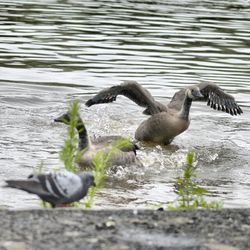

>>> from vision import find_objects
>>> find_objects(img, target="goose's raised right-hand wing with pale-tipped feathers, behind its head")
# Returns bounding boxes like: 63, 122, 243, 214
196, 82, 243, 115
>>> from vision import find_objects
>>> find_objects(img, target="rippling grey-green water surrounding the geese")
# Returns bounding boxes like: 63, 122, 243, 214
0, 0, 250, 208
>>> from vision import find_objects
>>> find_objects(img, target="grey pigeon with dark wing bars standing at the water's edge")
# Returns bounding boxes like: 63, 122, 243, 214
5, 170, 95, 208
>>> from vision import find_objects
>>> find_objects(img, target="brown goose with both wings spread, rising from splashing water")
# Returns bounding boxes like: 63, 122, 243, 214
85, 80, 243, 145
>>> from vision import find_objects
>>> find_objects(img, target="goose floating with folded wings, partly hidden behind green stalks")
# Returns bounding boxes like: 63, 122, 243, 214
54, 112, 141, 168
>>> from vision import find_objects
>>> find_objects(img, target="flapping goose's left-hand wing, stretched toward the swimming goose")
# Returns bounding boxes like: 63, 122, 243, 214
85, 81, 166, 115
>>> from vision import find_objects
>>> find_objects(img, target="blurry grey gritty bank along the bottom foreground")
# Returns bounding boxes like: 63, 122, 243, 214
0, 209, 250, 250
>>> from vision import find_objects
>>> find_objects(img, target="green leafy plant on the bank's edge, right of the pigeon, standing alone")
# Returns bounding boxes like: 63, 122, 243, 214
168, 152, 223, 210
